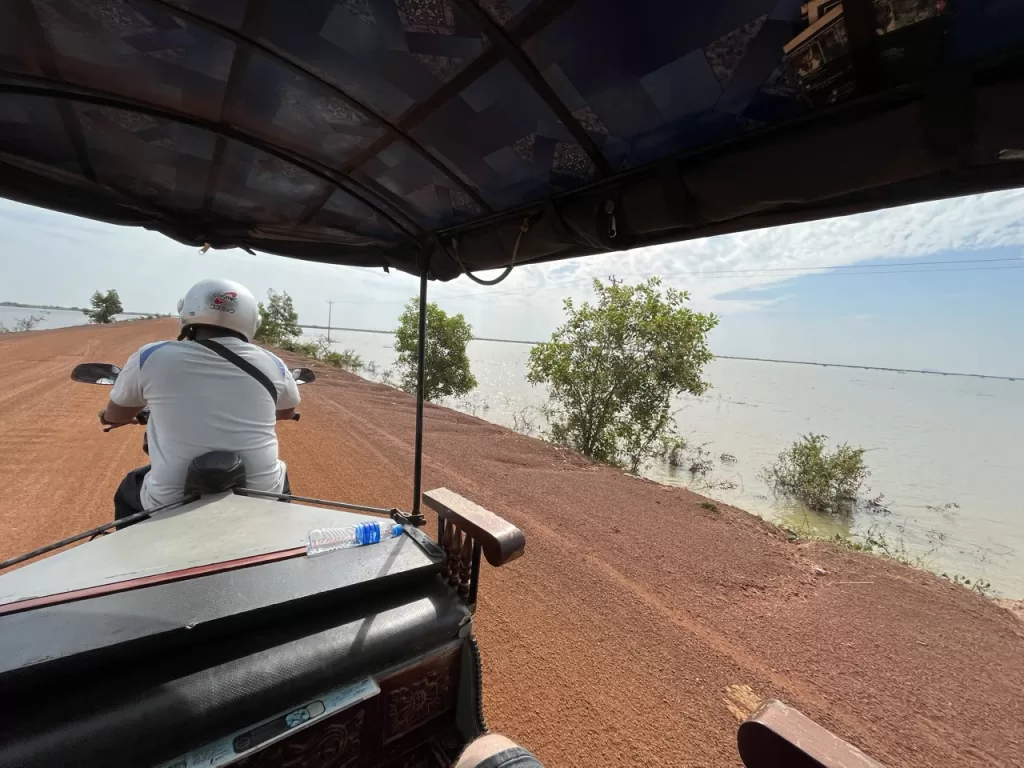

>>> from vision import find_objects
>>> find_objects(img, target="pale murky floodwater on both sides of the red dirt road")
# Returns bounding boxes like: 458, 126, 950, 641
6, 307, 1024, 598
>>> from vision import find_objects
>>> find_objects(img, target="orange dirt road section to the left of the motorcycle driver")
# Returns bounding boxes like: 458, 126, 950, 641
0, 323, 168, 559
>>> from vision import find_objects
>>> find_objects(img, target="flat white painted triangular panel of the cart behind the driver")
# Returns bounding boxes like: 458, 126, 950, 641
0, 494, 380, 605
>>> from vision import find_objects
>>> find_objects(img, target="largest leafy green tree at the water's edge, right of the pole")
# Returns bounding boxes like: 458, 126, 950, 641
526, 278, 718, 473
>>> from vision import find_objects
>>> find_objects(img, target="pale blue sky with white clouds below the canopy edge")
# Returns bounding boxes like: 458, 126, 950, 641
0, 190, 1024, 377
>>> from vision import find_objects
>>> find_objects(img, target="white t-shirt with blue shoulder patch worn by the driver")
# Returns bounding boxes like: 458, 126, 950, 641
111, 336, 299, 509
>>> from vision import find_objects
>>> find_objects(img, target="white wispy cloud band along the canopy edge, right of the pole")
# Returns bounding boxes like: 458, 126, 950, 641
432, 190, 1024, 312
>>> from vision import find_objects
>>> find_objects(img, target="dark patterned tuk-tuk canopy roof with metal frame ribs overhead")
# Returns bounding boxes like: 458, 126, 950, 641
0, 0, 1024, 280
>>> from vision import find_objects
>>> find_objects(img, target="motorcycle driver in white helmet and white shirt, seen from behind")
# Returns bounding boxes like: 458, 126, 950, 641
99, 280, 299, 520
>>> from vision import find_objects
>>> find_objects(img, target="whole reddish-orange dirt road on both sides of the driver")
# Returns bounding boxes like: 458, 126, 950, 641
0, 321, 1024, 768
